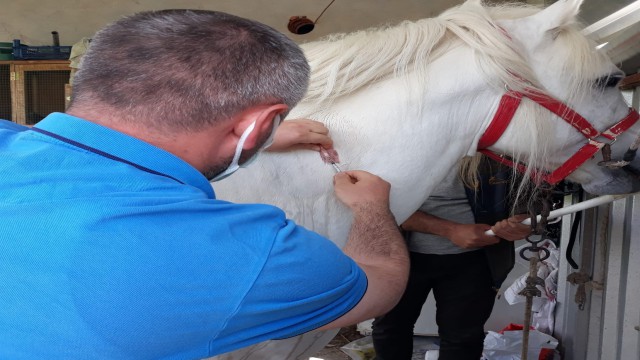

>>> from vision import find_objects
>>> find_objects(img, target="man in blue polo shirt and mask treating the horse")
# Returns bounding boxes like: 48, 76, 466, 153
0, 10, 408, 359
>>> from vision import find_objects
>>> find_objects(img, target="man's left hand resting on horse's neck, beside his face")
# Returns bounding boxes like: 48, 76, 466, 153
266, 119, 333, 151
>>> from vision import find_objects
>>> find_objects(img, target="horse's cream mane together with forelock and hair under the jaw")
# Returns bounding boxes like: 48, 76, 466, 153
302, 1, 607, 208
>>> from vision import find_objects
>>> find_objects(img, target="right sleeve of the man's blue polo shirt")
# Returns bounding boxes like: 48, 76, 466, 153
222, 220, 367, 339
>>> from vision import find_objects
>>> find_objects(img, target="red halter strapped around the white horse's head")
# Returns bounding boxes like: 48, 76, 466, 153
478, 91, 640, 185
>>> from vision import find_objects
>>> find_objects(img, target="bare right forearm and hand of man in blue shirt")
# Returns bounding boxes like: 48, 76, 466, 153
320, 171, 409, 330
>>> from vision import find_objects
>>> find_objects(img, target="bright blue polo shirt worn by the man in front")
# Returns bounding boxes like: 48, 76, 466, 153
0, 113, 367, 359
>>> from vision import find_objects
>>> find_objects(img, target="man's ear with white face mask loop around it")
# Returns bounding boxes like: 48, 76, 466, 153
233, 104, 289, 150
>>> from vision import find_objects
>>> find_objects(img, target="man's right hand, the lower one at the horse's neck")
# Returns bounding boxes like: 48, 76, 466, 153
333, 170, 391, 212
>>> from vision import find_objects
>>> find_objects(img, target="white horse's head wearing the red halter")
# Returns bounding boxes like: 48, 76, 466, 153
480, 0, 640, 194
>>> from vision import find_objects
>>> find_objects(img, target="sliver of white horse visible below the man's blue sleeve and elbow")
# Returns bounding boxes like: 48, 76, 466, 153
209, 329, 338, 360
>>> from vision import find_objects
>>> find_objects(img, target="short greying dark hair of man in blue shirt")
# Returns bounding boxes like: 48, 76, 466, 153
71, 10, 309, 131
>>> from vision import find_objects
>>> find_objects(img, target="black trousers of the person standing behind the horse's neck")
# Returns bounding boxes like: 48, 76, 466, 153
372, 250, 496, 360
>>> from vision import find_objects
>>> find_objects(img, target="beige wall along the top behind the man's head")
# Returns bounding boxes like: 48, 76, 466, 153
0, 0, 462, 46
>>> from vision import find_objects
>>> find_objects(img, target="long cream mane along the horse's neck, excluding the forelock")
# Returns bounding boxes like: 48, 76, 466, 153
302, 3, 539, 102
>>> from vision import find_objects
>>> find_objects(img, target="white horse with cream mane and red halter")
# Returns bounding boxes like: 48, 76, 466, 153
214, 0, 640, 359
